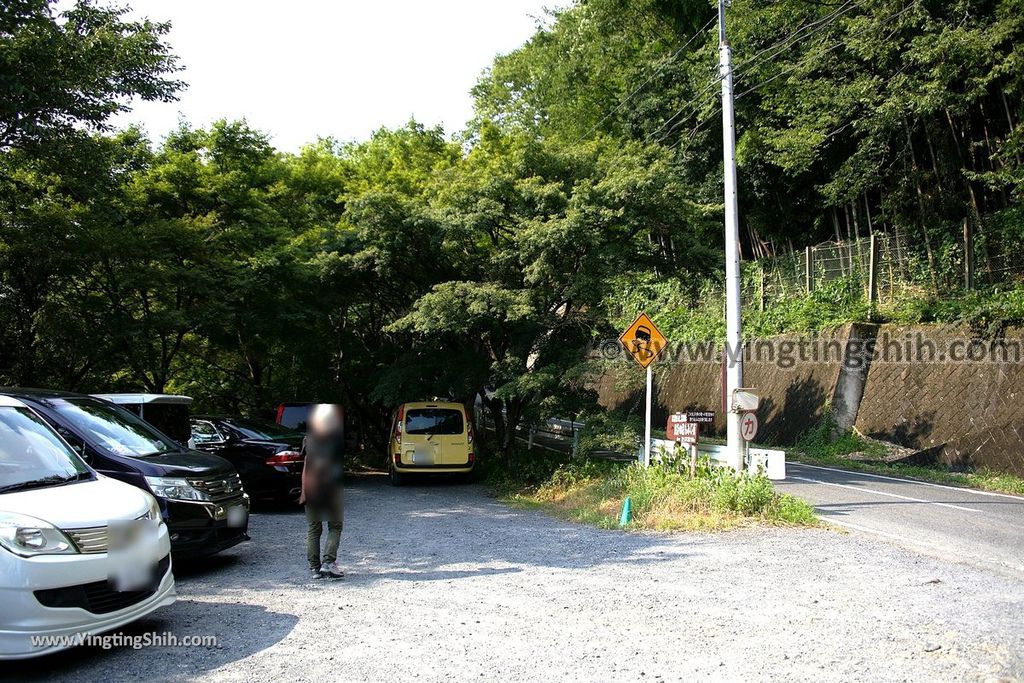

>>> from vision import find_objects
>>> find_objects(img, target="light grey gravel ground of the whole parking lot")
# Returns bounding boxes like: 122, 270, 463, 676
8, 477, 1024, 682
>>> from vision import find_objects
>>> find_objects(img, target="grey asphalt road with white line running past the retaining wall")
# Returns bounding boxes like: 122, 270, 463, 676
777, 462, 1024, 577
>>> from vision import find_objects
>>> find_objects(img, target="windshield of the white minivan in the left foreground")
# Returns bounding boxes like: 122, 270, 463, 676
0, 407, 90, 493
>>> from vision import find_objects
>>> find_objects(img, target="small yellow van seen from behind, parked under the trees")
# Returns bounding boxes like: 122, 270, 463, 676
387, 401, 476, 486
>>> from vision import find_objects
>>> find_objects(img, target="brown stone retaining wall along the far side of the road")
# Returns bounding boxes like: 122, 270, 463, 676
596, 325, 1024, 474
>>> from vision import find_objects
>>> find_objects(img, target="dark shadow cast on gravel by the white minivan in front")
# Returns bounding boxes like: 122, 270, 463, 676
2, 592, 298, 681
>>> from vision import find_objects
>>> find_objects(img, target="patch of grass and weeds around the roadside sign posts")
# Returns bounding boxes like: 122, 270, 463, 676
477, 453, 818, 530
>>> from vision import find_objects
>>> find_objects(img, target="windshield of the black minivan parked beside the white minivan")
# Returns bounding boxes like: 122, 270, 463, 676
49, 398, 181, 458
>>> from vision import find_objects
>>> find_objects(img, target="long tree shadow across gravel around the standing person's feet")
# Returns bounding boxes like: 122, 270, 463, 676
157, 474, 702, 600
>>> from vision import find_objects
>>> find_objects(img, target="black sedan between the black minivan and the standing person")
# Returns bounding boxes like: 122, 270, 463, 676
191, 416, 303, 503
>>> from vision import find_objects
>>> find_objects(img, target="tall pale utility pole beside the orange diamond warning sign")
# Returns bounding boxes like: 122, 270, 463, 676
718, 0, 746, 472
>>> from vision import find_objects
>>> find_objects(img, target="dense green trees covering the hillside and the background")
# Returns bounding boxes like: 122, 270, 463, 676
0, 0, 1024, 452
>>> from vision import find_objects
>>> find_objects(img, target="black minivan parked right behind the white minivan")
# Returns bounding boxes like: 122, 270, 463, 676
0, 389, 249, 559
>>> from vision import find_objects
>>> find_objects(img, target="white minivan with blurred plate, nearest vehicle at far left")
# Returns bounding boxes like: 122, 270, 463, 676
0, 396, 175, 659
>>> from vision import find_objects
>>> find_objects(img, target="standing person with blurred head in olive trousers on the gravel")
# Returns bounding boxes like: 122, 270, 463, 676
299, 403, 345, 579
